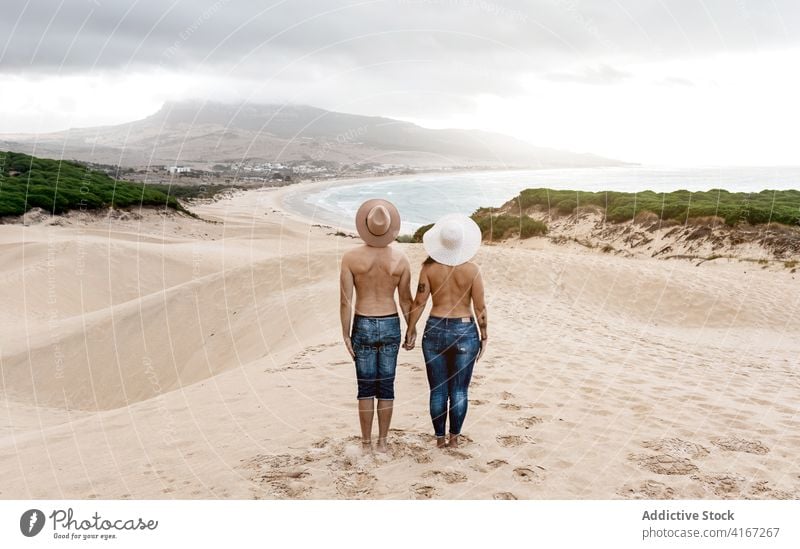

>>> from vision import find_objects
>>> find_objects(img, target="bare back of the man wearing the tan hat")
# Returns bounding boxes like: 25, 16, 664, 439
342, 246, 409, 316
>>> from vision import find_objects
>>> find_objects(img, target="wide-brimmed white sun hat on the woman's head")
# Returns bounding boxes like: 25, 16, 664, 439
422, 214, 481, 267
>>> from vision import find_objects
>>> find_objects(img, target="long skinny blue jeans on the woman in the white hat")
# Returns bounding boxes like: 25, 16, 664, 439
422, 316, 481, 437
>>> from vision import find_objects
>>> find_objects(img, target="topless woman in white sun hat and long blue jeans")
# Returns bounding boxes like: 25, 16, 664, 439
404, 214, 488, 448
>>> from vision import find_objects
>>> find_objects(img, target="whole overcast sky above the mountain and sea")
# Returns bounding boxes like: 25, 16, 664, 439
0, 0, 800, 166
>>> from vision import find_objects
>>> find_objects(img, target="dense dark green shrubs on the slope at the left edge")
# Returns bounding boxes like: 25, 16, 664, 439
0, 152, 185, 217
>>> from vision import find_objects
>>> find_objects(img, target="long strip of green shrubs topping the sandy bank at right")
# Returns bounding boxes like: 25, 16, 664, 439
515, 189, 800, 226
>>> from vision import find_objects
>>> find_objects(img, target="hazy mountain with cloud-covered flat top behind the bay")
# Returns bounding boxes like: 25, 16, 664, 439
0, 101, 624, 168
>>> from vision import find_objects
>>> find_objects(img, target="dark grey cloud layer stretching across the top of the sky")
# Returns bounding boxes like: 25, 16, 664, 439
0, 0, 800, 73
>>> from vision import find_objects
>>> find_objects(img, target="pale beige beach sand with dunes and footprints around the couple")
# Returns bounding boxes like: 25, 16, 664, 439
0, 189, 800, 499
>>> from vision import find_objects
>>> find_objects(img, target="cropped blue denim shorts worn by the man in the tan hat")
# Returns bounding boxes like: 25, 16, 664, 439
350, 314, 400, 400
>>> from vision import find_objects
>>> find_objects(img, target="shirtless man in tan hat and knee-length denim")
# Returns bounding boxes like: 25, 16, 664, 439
339, 199, 412, 452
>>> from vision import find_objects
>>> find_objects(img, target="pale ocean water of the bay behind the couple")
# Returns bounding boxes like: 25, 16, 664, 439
284, 166, 800, 234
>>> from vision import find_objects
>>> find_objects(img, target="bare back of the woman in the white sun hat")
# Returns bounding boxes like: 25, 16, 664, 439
425, 263, 479, 317
